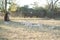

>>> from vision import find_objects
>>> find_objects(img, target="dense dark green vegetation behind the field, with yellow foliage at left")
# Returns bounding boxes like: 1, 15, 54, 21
0, 0, 60, 18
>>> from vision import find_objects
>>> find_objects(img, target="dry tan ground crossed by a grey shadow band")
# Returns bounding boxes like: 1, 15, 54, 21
0, 18, 60, 40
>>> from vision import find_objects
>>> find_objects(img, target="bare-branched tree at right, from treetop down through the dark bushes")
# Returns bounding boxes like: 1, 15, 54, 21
47, 0, 59, 17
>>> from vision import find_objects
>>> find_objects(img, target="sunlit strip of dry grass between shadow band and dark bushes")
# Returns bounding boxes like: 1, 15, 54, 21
10, 17, 60, 26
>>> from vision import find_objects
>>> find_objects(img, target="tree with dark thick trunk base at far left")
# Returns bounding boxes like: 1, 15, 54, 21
0, 0, 12, 21
